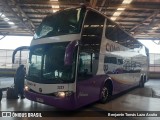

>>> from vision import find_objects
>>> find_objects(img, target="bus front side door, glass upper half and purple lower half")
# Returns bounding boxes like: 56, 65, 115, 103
77, 52, 100, 105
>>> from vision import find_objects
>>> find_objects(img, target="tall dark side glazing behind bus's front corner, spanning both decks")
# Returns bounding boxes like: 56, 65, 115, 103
78, 11, 105, 80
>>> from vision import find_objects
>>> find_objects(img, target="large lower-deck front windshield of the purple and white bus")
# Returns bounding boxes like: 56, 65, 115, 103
27, 42, 75, 84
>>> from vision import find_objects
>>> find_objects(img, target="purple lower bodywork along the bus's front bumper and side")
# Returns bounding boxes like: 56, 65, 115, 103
25, 75, 138, 110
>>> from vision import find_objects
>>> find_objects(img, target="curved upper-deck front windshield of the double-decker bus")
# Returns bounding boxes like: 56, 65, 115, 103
33, 8, 85, 39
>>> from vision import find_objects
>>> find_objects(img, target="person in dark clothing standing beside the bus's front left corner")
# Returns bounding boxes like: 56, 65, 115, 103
14, 65, 26, 99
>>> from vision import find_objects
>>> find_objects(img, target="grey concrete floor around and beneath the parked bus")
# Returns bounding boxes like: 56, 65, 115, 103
0, 78, 160, 120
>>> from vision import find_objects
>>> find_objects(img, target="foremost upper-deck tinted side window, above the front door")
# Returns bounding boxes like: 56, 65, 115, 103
81, 11, 105, 52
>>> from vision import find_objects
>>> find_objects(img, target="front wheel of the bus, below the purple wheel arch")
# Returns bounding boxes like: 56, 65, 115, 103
100, 85, 110, 103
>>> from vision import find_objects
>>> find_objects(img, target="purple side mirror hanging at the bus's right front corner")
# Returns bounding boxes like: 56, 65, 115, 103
64, 41, 78, 65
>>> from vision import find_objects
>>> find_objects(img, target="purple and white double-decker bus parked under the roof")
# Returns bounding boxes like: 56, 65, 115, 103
13, 6, 149, 110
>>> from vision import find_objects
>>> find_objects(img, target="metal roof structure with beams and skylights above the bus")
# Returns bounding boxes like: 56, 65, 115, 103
0, 0, 160, 40
